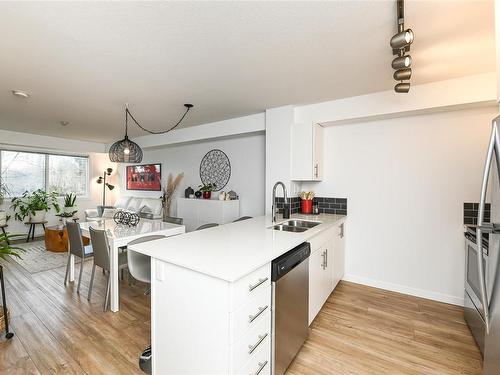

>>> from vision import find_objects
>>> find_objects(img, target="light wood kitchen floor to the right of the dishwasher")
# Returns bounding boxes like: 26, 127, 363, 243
287, 282, 482, 375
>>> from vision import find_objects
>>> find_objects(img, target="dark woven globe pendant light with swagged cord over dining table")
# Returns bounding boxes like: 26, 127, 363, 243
109, 104, 193, 163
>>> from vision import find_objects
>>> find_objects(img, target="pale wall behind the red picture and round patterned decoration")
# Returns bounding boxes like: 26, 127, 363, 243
119, 134, 265, 216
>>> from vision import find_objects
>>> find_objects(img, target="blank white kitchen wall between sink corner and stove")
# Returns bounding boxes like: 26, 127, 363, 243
305, 106, 497, 304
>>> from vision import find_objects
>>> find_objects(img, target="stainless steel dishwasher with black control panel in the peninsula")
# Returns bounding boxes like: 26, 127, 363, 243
271, 242, 311, 375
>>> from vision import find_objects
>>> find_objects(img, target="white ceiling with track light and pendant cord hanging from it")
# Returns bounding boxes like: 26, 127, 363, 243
0, 0, 495, 143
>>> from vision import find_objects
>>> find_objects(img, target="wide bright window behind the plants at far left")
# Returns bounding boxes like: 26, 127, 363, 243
0, 150, 89, 197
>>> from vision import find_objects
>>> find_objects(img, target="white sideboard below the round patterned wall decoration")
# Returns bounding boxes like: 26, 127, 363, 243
177, 198, 240, 232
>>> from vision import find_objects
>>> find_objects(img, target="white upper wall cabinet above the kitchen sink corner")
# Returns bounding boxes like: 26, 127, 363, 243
291, 124, 323, 181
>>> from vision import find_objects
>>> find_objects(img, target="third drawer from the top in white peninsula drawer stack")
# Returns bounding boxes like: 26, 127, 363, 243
230, 311, 271, 372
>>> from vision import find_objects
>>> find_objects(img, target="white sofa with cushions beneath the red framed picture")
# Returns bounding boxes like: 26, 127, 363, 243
85, 196, 163, 221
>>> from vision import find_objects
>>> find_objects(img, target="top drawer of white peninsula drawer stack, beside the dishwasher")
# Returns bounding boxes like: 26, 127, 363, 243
230, 263, 271, 311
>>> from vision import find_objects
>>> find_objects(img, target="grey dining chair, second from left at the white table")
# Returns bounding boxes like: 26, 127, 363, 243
87, 227, 127, 311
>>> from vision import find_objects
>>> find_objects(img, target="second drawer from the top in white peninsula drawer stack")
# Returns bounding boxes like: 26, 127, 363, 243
229, 285, 271, 342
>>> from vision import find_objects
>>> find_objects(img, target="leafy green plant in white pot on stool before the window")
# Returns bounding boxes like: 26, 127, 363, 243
10, 189, 60, 222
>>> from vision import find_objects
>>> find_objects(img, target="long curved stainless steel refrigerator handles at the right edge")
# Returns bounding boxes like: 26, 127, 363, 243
476, 117, 500, 334
